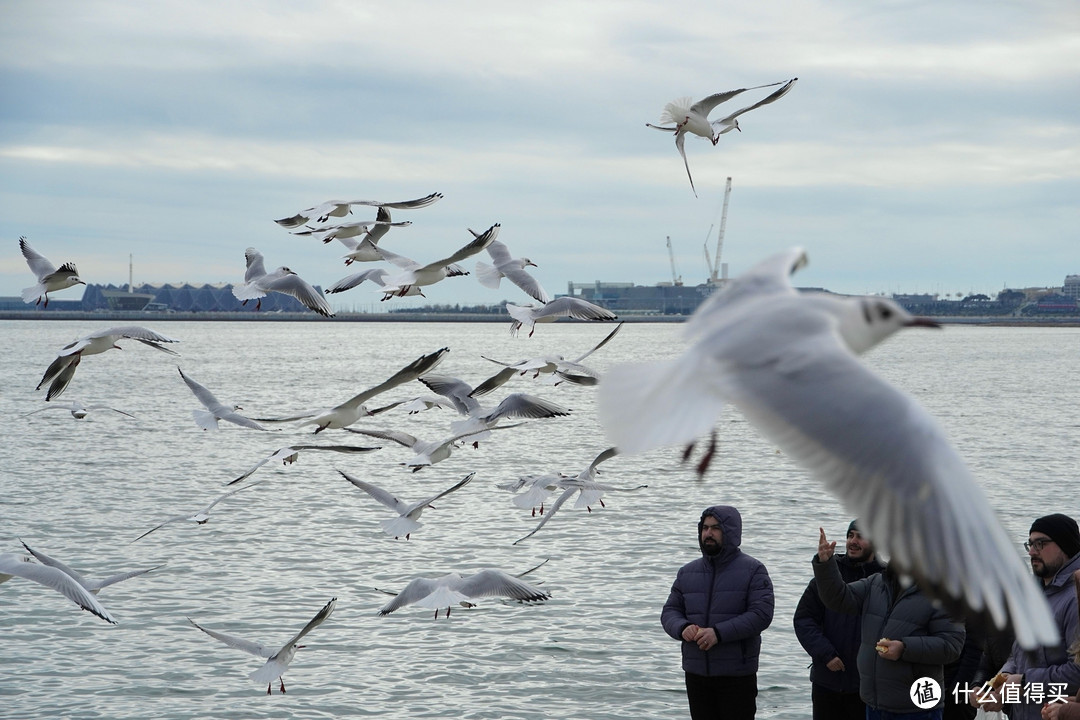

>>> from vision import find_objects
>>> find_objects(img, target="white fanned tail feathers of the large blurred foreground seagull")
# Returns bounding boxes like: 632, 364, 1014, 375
597, 353, 724, 454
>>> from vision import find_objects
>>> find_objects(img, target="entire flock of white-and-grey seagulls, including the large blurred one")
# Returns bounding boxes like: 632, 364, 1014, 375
12, 79, 1058, 693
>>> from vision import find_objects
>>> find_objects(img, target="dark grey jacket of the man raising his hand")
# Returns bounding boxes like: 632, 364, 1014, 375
813, 555, 966, 712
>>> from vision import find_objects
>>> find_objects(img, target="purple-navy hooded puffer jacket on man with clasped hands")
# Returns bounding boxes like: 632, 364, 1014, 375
660, 505, 774, 676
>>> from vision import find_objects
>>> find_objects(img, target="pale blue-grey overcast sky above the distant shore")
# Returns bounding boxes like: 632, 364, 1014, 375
0, 0, 1080, 309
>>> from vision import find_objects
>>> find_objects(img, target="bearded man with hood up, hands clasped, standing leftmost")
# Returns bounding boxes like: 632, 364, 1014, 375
660, 505, 773, 720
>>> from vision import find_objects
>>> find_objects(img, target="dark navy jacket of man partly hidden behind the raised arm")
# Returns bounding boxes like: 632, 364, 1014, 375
793, 555, 885, 693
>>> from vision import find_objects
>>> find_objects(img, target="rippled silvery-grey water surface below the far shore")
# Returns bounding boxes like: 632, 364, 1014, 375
0, 321, 1080, 720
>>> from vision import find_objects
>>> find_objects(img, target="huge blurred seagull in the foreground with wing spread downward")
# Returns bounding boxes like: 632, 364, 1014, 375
597, 247, 1058, 650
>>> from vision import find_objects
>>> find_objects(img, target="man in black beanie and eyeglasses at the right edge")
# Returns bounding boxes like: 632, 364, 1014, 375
972, 513, 1080, 720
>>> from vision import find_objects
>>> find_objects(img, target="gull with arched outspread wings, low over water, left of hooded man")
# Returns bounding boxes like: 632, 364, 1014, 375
379, 569, 551, 620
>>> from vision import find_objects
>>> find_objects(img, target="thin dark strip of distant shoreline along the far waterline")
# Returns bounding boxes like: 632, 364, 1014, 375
0, 310, 1080, 327
